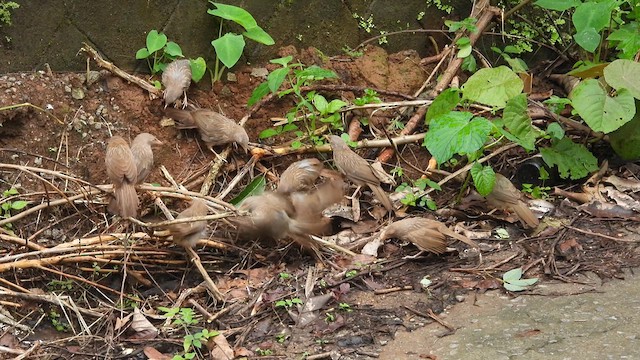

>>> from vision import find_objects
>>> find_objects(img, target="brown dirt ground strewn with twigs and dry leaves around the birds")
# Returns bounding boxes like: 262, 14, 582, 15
0, 48, 640, 359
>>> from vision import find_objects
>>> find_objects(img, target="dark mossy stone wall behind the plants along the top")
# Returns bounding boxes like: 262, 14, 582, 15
0, 0, 470, 73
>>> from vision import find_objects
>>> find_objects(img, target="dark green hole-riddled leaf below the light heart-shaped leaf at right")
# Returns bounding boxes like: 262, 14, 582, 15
540, 137, 598, 180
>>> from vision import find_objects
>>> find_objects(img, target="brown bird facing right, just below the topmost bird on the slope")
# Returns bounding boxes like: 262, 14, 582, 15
166, 108, 249, 156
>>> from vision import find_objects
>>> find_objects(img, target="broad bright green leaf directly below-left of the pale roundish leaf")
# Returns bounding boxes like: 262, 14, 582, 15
424, 111, 493, 165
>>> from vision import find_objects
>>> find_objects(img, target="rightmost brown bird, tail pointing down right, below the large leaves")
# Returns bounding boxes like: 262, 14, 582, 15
486, 174, 540, 228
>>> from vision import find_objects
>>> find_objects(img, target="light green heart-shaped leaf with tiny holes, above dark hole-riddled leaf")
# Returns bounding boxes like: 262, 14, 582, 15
569, 79, 636, 133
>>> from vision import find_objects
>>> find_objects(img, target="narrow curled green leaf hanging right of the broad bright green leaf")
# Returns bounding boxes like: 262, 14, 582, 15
502, 94, 538, 151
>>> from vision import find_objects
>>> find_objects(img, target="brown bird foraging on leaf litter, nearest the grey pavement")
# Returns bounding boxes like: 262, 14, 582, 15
380, 218, 478, 254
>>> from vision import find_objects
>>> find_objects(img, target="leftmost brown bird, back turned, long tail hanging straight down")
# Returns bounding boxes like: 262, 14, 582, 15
104, 136, 138, 217
